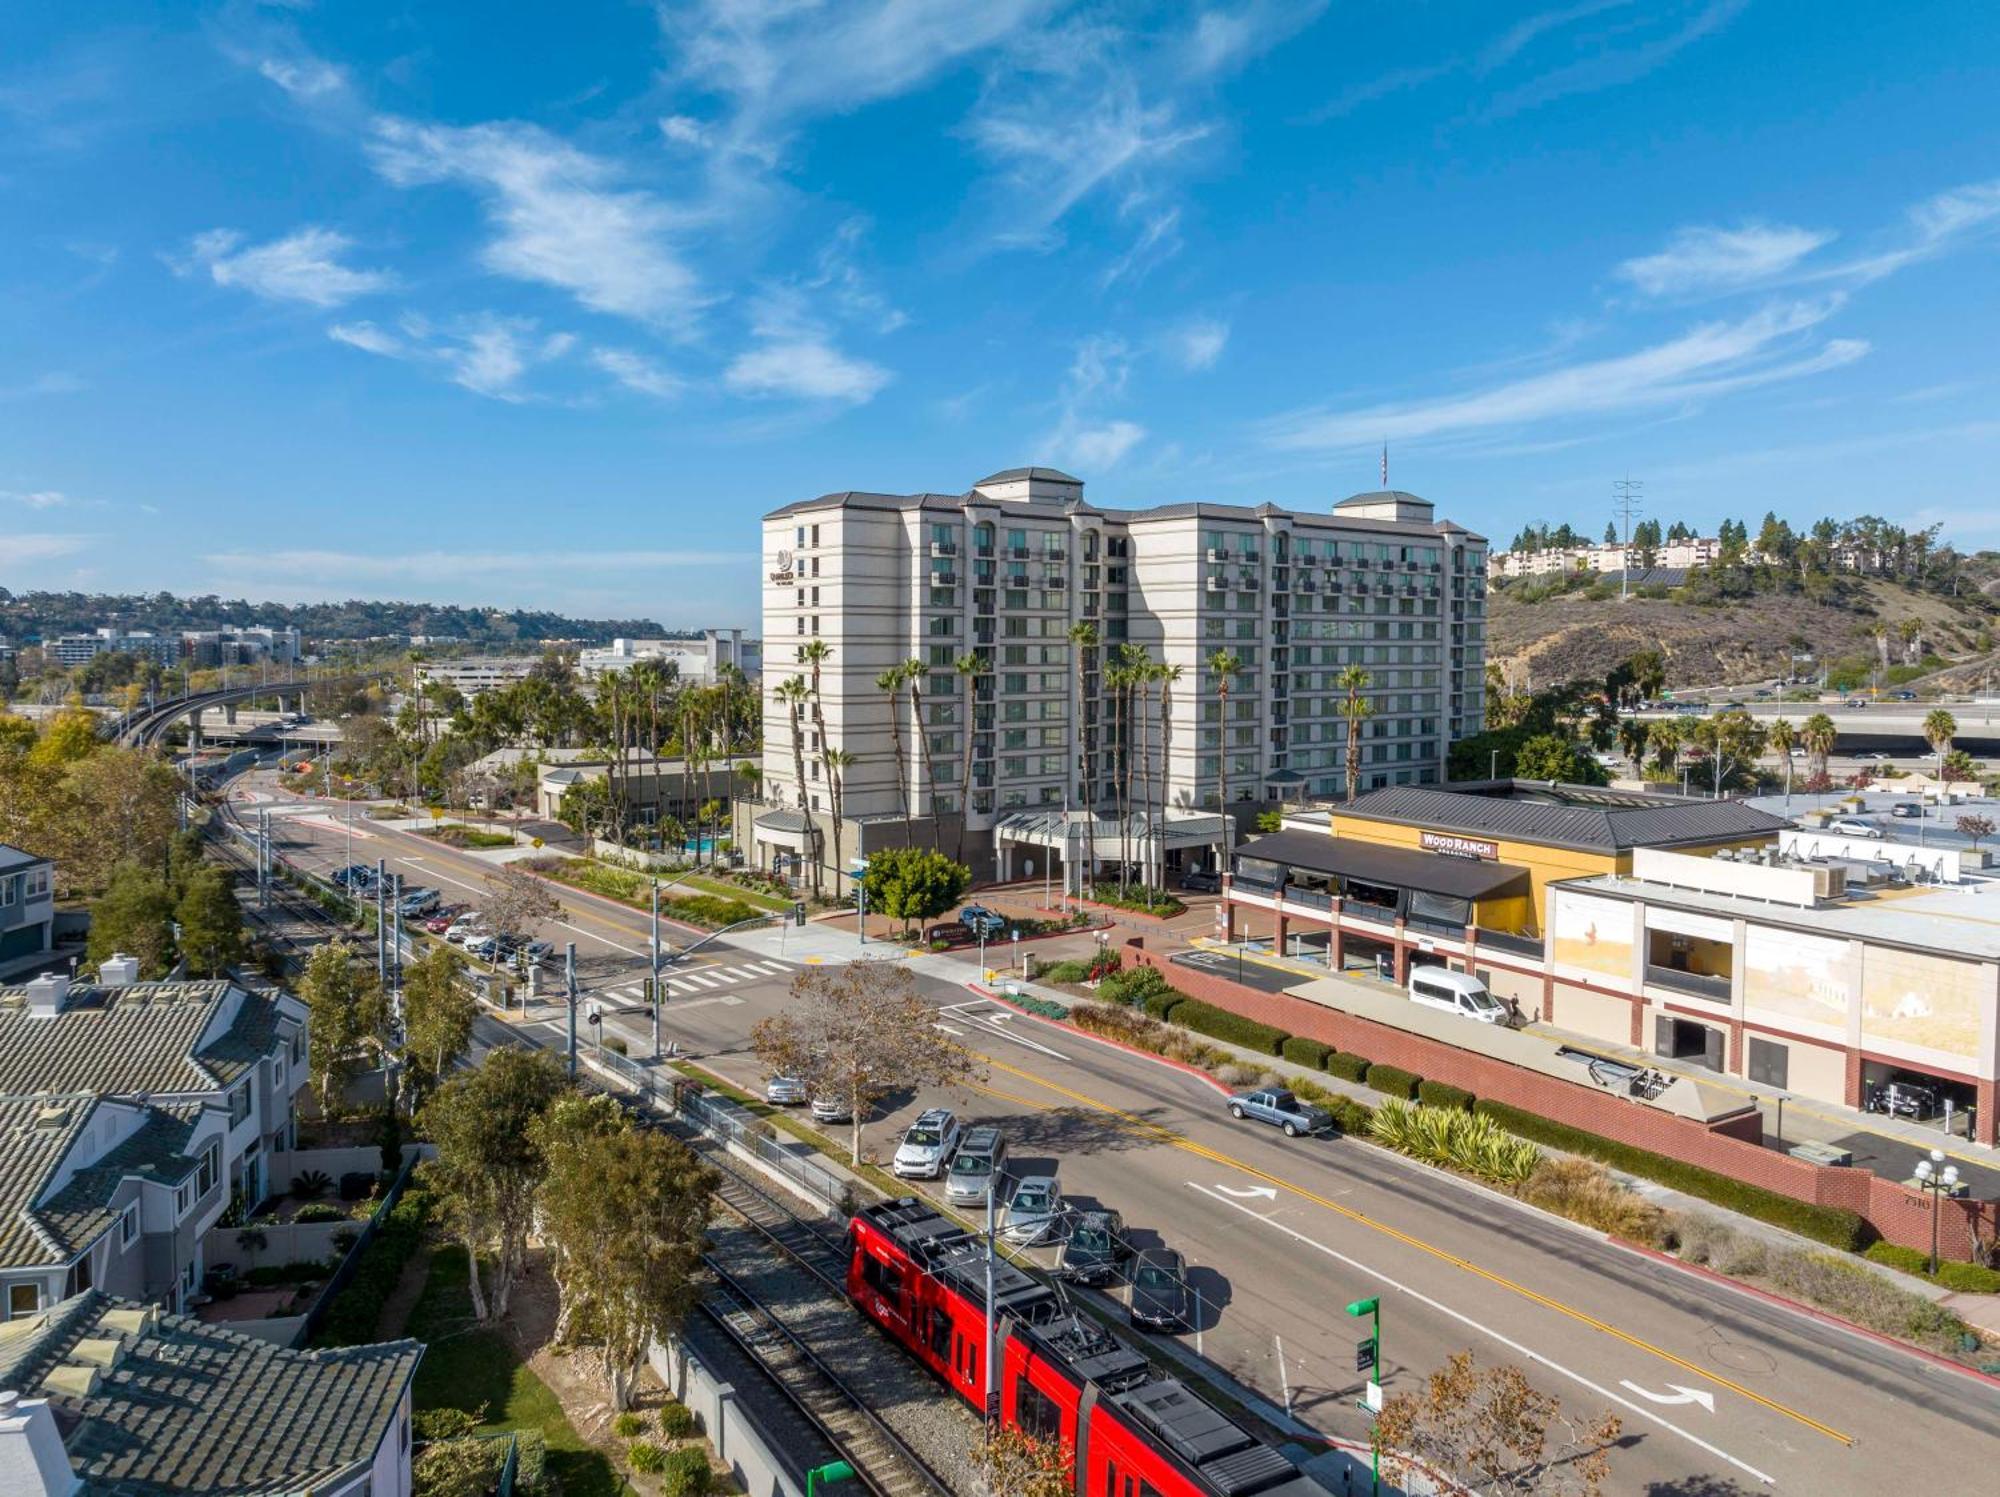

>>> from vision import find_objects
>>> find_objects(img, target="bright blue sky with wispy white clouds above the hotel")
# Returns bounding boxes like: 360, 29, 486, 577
0, 0, 2000, 624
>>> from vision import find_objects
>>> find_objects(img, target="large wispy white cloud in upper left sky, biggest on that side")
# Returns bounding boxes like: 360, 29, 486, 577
372, 118, 702, 332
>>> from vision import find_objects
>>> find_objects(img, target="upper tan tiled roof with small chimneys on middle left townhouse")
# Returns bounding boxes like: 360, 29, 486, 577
0, 981, 296, 1097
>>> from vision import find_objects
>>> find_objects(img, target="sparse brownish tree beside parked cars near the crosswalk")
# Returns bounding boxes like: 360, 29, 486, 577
750, 961, 978, 1165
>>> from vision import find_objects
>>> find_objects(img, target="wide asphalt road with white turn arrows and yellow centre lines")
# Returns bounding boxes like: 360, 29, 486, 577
242, 772, 2000, 1493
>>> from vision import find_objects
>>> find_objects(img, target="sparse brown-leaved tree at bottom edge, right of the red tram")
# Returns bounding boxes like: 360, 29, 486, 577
1376, 1351, 1624, 1497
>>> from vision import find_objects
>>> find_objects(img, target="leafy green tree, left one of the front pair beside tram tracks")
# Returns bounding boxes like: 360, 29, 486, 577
418, 1049, 568, 1321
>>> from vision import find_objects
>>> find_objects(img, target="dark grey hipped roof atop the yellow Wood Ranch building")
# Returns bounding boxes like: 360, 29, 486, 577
1334, 781, 1790, 853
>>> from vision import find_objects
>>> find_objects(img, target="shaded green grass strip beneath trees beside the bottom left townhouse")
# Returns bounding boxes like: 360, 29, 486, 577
406, 1247, 626, 1497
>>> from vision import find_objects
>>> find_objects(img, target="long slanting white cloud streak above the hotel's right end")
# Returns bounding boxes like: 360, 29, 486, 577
1264, 298, 1868, 450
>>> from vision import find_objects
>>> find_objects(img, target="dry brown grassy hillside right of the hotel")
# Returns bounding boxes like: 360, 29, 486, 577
1488, 580, 1994, 688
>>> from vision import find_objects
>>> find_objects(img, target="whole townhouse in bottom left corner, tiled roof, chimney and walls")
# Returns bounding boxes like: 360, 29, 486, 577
0, 1289, 424, 1497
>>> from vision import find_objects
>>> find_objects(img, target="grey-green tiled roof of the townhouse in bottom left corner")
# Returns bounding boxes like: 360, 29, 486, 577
0, 1291, 424, 1497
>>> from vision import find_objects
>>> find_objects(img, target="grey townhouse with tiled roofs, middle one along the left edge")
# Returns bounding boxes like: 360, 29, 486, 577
0, 972, 308, 1317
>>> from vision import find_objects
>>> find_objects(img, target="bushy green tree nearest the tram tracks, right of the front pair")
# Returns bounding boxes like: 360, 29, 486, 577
540, 1096, 722, 1409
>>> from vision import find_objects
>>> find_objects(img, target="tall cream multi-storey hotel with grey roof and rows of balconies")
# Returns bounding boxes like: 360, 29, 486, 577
738, 468, 1486, 881
